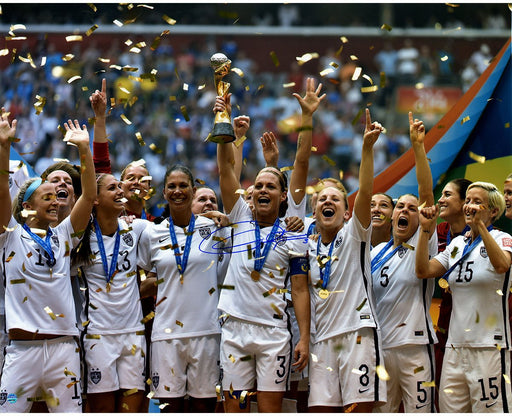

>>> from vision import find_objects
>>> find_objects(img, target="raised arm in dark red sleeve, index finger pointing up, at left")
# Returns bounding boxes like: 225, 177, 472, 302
89, 79, 112, 173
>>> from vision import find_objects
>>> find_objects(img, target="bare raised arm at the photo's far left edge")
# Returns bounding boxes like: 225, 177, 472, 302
0, 107, 17, 234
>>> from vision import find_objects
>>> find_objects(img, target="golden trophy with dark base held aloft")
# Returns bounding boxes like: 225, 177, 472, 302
208, 53, 235, 143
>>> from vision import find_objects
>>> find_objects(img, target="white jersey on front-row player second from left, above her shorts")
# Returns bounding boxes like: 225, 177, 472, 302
81, 219, 149, 335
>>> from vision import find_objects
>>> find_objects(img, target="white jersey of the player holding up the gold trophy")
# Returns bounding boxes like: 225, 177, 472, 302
219, 198, 307, 327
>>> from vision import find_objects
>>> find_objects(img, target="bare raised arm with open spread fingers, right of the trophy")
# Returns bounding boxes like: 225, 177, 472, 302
290, 78, 326, 204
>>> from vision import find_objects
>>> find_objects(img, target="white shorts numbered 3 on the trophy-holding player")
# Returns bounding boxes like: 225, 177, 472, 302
220, 317, 291, 392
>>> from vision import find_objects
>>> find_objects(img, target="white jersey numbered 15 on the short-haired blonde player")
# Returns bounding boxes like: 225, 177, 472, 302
435, 230, 512, 349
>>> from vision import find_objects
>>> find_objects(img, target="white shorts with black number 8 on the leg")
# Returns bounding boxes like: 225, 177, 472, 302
308, 328, 386, 407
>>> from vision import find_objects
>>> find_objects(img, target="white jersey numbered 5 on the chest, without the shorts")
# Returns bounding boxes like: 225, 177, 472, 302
371, 227, 437, 348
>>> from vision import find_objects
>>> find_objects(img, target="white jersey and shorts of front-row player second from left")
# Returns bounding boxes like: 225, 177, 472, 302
80, 219, 148, 393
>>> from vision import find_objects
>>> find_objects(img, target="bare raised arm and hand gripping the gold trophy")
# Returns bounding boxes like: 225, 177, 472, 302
214, 96, 241, 214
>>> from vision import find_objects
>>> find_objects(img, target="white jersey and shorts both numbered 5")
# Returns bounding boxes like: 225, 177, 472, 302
371, 227, 437, 413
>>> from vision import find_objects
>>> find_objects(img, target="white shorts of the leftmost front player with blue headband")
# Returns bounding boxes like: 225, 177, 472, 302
0, 336, 82, 413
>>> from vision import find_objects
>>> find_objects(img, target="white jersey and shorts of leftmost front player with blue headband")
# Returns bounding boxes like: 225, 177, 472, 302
0, 217, 82, 413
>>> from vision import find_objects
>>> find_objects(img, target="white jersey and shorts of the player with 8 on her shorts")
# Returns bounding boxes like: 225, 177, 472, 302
309, 215, 386, 407
